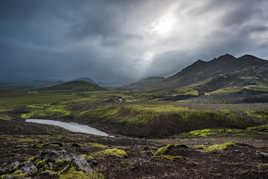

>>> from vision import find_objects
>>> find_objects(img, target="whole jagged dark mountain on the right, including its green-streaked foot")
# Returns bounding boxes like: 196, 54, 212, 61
133, 54, 268, 102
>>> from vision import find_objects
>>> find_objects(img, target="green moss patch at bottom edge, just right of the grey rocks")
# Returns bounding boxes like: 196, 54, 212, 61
59, 167, 104, 179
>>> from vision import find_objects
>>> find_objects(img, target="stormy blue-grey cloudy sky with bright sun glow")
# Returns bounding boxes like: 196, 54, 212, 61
0, 0, 268, 84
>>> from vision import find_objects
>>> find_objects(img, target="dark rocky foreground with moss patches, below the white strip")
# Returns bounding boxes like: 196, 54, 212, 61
0, 120, 268, 179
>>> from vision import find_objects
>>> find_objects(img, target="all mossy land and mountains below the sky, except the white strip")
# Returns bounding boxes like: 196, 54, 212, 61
0, 55, 268, 178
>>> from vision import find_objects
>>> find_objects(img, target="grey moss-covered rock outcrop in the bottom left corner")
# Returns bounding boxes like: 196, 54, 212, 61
0, 150, 93, 178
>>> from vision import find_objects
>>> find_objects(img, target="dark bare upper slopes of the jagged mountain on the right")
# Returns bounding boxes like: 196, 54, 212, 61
165, 54, 268, 89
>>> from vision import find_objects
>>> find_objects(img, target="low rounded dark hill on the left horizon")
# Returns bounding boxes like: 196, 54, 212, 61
42, 80, 104, 91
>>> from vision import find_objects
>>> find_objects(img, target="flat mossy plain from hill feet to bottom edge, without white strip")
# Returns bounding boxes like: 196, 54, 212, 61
0, 90, 268, 178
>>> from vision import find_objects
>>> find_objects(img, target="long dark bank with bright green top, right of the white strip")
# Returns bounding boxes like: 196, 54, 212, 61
85, 103, 263, 137
